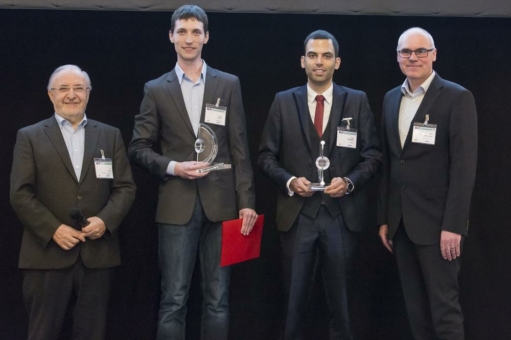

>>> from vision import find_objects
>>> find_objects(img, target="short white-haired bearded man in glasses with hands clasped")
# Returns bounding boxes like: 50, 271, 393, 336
10, 65, 135, 340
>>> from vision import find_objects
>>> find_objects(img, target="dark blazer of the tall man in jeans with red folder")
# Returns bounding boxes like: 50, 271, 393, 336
128, 66, 255, 225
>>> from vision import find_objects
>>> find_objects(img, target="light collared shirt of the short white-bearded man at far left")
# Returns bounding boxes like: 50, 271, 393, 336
55, 113, 87, 180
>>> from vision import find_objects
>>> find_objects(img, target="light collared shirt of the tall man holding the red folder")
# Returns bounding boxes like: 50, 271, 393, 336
167, 60, 207, 176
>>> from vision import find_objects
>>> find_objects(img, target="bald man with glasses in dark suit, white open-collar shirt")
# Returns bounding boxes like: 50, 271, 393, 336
379, 28, 477, 340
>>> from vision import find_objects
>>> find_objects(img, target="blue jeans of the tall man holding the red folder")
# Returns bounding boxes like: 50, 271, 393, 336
157, 198, 231, 340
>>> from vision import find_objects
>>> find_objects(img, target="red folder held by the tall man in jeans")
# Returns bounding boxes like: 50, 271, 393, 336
220, 215, 264, 267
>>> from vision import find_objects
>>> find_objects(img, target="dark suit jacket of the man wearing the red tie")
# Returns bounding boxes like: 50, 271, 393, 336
257, 84, 382, 231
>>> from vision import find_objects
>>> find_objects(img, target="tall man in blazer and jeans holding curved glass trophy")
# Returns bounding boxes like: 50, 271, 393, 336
128, 5, 257, 339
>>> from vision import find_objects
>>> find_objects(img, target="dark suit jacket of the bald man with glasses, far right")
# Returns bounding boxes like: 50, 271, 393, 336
379, 74, 477, 245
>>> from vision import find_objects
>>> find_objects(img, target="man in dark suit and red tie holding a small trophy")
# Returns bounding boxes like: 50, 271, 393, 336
257, 31, 381, 340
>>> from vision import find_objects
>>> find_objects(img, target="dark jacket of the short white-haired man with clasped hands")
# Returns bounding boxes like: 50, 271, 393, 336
10, 117, 135, 269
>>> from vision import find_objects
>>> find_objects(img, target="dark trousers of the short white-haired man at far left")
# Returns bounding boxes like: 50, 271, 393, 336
22, 258, 113, 340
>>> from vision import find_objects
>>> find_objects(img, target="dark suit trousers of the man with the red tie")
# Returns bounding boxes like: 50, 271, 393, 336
280, 205, 358, 340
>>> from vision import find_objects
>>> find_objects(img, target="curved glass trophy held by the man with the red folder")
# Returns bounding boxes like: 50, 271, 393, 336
195, 123, 226, 173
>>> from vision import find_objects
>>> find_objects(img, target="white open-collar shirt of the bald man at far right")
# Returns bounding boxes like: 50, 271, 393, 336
398, 71, 435, 147
